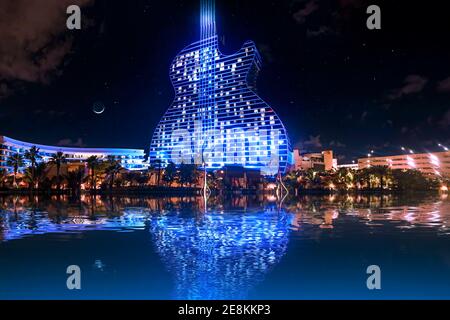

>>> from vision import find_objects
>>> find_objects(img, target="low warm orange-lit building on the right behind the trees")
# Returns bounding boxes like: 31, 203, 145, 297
358, 151, 450, 178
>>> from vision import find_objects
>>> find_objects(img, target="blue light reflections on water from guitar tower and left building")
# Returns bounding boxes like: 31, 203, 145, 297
0, 204, 291, 299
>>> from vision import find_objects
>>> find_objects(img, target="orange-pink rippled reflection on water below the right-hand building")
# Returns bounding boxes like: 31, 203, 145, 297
287, 194, 450, 232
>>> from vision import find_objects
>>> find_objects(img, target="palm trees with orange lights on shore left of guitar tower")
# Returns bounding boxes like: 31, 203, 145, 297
0, 146, 199, 194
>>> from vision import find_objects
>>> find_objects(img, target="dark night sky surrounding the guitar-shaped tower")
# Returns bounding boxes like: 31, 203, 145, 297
0, 0, 450, 163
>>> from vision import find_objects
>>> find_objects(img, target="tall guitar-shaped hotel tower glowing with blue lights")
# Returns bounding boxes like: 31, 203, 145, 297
150, 0, 293, 175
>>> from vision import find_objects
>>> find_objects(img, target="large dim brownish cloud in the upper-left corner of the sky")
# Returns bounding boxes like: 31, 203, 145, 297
0, 0, 95, 98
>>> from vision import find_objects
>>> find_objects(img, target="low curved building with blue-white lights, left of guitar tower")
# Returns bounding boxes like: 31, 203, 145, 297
0, 136, 148, 171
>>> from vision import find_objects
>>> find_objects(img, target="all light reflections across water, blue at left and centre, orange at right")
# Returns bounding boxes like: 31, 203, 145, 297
0, 196, 450, 299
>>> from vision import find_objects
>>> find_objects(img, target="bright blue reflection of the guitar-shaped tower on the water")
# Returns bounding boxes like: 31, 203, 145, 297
150, 211, 290, 299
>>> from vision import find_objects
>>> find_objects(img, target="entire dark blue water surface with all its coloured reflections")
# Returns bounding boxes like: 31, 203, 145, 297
0, 195, 450, 299
